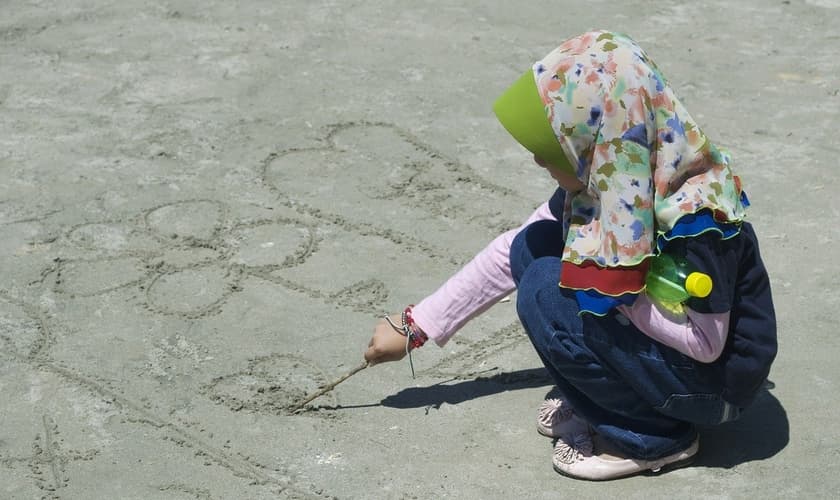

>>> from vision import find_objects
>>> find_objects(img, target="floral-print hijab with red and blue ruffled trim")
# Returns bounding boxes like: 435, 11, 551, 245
533, 31, 748, 314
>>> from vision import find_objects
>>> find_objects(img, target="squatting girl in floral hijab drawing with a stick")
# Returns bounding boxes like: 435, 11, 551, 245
365, 31, 776, 479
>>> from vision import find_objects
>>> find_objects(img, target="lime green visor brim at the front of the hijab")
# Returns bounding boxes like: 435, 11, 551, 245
493, 70, 575, 176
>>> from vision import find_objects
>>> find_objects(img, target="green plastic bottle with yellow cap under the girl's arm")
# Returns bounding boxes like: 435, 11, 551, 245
645, 253, 713, 304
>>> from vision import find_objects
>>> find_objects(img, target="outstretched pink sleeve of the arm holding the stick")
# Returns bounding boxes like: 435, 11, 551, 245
413, 202, 557, 346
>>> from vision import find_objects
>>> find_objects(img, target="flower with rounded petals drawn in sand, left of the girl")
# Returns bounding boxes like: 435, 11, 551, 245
55, 200, 316, 318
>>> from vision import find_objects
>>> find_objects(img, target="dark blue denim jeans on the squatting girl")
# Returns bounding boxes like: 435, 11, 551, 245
510, 221, 740, 460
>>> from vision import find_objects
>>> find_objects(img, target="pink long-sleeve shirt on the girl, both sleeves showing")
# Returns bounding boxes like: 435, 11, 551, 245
413, 202, 729, 363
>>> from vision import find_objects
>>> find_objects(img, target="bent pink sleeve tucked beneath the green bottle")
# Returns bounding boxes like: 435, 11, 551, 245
618, 294, 729, 363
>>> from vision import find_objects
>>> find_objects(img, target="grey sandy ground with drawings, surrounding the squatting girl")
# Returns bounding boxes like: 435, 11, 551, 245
0, 0, 840, 499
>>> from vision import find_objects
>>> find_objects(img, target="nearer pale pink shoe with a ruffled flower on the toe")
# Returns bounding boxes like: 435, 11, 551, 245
552, 433, 700, 481
